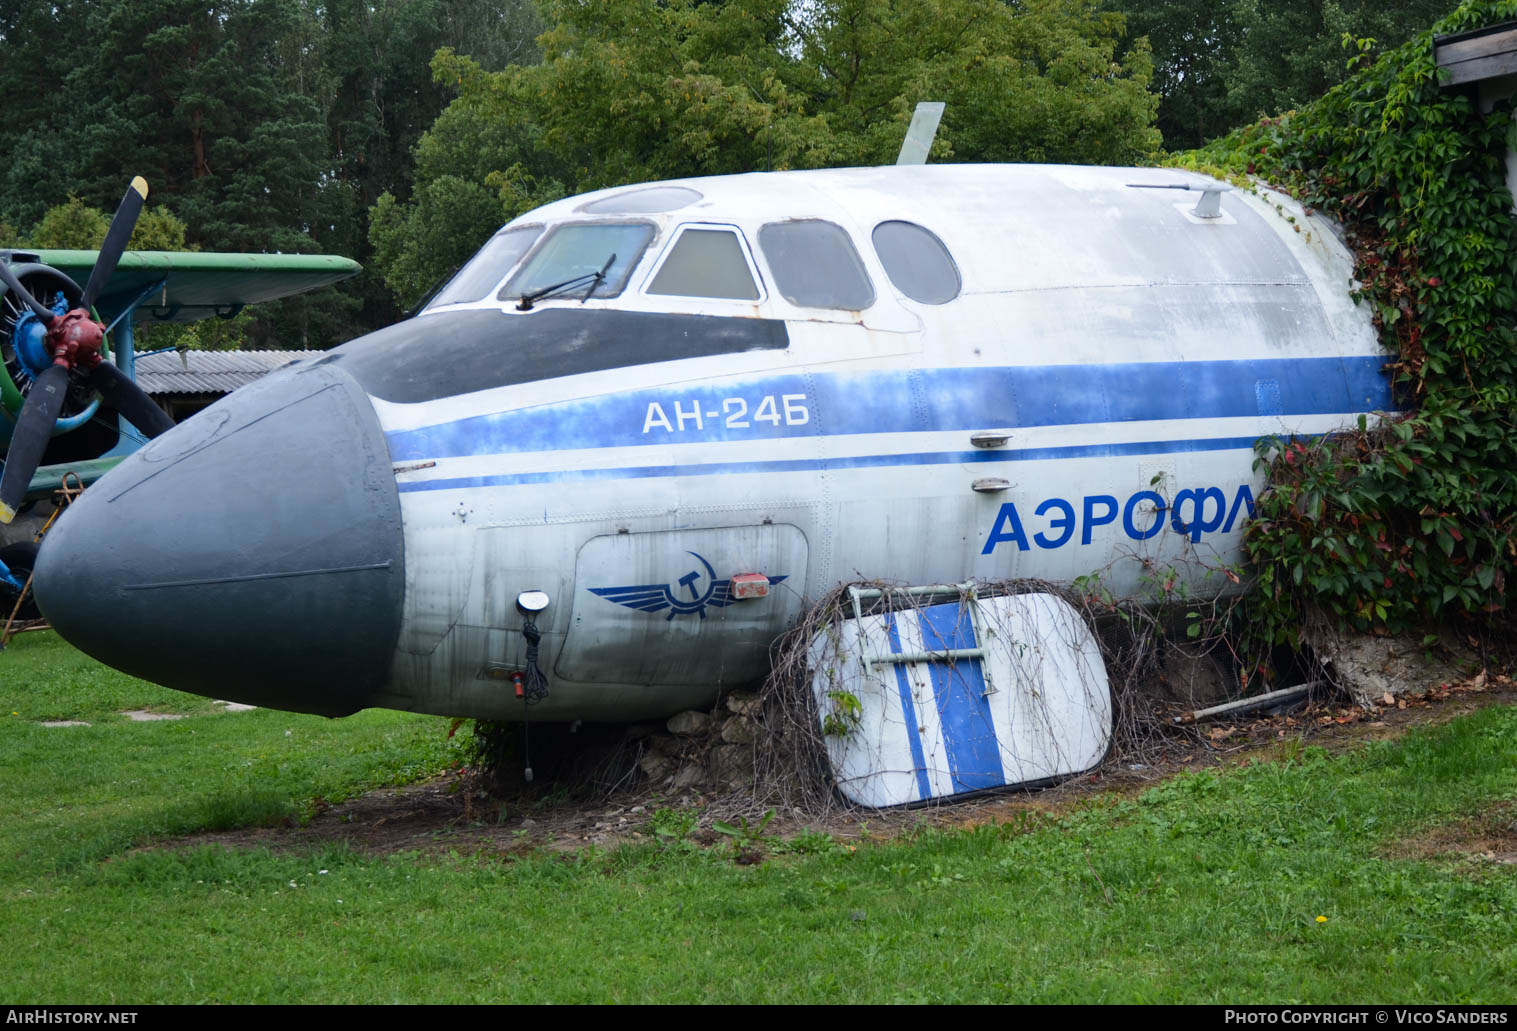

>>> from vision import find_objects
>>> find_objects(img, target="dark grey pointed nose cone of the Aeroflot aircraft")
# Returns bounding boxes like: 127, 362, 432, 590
33, 362, 405, 716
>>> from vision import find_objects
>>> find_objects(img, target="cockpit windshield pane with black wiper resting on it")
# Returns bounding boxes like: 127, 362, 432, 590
498, 221, 654, 300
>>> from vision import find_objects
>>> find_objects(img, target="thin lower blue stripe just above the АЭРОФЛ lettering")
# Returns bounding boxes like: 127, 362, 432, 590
397, 437, 1258, 494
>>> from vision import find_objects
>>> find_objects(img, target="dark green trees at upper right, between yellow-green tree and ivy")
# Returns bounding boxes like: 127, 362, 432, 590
1104, 0, 1458, 150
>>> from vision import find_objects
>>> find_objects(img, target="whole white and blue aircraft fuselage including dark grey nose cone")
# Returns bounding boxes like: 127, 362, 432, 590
38, 165, 1391, 720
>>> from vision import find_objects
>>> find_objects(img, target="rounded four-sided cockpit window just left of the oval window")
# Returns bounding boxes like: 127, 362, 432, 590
759, 218, 874, 311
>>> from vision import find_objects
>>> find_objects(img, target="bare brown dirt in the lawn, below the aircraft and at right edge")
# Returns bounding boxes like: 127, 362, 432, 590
150, 675, 1517, 863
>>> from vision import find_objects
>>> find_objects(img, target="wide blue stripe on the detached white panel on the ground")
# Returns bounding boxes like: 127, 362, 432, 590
916, 602, 1006, 794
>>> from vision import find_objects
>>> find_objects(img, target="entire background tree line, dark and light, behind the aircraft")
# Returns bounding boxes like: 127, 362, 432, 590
0, 0, 1480, 347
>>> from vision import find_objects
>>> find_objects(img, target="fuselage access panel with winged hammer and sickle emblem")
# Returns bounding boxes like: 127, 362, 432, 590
554, 523, 807, 687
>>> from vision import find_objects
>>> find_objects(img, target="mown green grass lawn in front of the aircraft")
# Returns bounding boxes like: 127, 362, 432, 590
0, 634, 1517, 1002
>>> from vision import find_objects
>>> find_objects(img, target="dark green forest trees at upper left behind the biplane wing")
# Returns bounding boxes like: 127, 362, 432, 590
0, 0, 542, 347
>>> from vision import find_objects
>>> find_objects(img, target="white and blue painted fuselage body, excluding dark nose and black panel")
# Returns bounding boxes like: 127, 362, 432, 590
361, 165, 1390, 720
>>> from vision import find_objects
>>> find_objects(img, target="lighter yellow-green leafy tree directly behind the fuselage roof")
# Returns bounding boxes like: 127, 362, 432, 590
370, 0, 1159, 302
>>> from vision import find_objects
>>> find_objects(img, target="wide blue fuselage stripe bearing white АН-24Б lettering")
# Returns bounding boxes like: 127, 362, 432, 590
387, 355, 1393, 462
